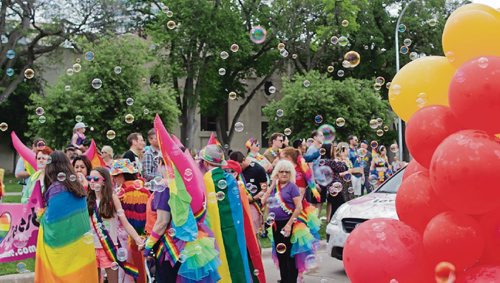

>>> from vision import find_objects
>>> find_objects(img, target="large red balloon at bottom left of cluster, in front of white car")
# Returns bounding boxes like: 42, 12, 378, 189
343, 218, 432, 283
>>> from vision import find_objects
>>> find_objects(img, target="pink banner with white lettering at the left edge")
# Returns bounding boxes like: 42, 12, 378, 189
0, 182, 41, 263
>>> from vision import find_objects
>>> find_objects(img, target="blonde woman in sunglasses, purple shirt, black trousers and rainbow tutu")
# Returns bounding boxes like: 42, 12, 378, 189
263, 160, 317, 283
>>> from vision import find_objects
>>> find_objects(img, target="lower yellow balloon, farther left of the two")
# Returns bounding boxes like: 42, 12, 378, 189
389, 56, 456, 121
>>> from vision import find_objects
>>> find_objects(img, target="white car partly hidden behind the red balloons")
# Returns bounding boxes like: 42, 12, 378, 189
326, 169, 404, 260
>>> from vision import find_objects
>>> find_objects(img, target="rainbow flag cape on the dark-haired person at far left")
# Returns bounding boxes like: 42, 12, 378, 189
35, 183, 98, 283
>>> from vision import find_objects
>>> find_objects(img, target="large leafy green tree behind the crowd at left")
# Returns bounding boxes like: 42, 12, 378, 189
28, 35, 179, 153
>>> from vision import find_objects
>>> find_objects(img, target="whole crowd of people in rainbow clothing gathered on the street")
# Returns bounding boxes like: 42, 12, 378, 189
11, 123, 404, 283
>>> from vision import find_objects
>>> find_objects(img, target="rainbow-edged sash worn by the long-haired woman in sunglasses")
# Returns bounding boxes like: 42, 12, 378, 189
92, 206, 139, 279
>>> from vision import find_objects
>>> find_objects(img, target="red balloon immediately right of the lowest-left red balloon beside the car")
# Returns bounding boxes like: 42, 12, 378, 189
423, 211, 484, 272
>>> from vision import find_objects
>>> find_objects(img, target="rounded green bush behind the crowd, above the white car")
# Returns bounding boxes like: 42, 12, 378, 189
263, 71, 396, 144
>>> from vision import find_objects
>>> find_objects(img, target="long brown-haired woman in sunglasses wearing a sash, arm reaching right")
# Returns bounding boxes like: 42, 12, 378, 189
87, 167, 144, 283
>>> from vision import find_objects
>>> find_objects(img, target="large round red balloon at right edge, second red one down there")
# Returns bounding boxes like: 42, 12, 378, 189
430, 131, 500, 214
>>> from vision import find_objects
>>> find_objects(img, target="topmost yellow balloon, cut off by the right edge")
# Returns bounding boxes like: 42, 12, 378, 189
442, 4, 500, 68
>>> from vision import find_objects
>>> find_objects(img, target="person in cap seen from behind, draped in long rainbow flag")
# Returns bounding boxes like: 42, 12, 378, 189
200, 144, 254, 282
